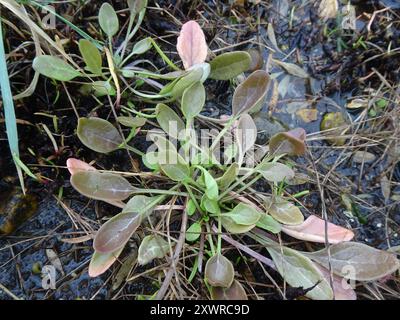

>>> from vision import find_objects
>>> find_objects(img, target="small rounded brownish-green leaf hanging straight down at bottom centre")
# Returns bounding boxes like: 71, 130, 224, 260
204, 253, 235, 288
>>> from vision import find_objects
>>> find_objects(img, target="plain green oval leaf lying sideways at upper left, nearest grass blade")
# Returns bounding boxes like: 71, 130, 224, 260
32, 56, 81, 81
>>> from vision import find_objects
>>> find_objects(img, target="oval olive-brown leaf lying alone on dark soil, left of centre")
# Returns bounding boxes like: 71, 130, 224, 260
77, 117, 123, 153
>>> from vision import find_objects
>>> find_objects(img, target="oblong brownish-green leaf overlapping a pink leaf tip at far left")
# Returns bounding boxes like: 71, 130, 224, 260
71, 171, 134, 200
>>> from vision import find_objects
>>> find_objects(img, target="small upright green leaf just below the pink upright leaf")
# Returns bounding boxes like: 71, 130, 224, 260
181, 81, 206, 121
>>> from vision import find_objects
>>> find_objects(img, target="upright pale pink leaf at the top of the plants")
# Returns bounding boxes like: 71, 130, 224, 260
176, 20, 208, 69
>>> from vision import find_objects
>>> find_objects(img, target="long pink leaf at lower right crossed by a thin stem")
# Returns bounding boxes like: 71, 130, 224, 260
282, 216, 354, 244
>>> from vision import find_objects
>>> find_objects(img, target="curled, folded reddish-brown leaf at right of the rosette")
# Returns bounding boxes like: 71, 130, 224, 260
269, 128, 306, 156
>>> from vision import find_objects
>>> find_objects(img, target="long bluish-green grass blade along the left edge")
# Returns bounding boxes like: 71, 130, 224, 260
0, 21, 25, 191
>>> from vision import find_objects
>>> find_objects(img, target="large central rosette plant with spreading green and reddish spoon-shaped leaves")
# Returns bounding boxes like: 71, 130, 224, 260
67, 65, 399, 299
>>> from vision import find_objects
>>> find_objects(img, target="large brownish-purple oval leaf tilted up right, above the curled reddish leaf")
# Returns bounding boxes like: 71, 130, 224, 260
232, 70, 270, 115
